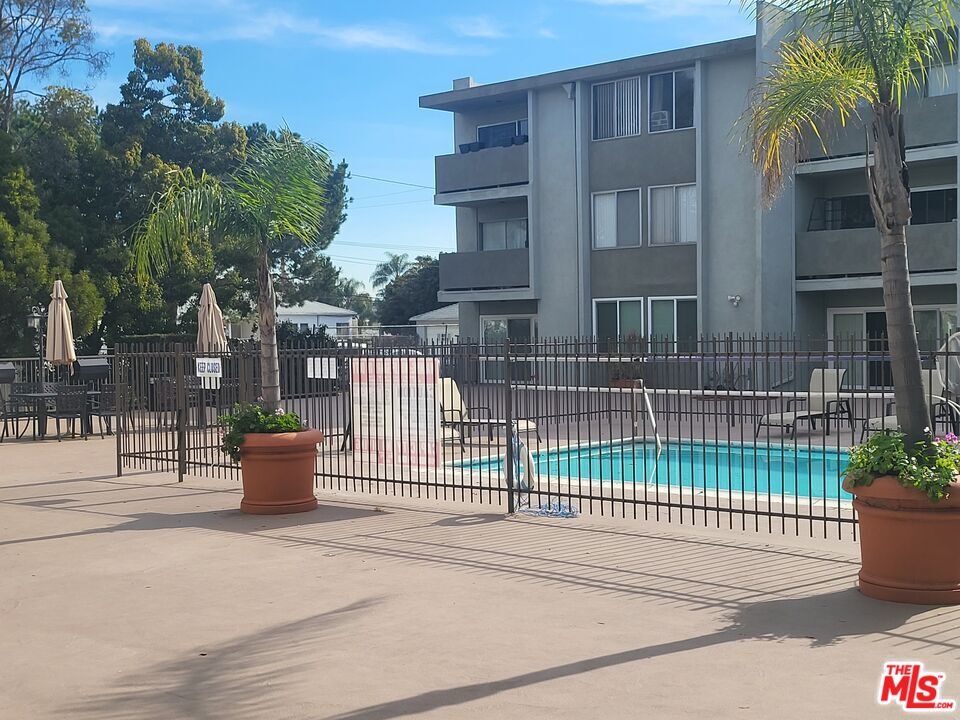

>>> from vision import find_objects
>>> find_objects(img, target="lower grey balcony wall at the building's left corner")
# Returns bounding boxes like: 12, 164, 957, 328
440, 248, 530, 300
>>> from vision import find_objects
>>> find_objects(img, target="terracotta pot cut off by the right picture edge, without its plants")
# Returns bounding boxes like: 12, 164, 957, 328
844, 476, 960, 605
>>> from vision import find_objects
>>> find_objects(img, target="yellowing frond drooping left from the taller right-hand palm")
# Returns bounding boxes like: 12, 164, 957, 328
741, 35, 876, 204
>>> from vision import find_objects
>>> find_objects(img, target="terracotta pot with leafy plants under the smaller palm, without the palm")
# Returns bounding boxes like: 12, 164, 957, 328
220, 404, 323, 515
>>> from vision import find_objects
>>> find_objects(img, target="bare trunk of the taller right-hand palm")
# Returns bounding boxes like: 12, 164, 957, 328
869, 103, 930, 448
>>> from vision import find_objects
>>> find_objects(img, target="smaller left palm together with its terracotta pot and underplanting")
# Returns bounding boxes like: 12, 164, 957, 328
133, 128, 333, 512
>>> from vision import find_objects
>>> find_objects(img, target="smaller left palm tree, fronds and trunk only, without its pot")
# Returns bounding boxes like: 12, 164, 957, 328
134, 129, 332, 410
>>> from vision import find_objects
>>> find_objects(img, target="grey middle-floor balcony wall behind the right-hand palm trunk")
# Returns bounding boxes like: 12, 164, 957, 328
797, 222, 957, 278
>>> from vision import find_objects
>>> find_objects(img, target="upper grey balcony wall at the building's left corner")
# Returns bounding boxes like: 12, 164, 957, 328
436, 144, 530, 195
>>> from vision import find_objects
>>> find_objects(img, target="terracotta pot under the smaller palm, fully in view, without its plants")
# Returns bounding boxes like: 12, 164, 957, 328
240, 430, 323, 515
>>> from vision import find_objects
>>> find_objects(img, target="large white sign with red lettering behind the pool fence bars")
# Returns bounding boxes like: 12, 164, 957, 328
350, 356, 442, 467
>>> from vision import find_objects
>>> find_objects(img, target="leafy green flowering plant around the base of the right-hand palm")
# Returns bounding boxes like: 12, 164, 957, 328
844, 432, 960, 502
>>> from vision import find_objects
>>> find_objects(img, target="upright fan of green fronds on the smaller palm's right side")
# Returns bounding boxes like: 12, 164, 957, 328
231, 129, 333, 250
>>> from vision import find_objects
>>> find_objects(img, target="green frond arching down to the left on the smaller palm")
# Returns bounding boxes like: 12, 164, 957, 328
132, 168, 226, 280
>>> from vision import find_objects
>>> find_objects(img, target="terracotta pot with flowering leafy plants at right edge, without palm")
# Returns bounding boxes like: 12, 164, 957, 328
843, 432, 960, 605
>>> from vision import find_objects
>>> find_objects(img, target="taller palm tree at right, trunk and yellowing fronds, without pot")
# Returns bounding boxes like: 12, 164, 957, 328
742, 0, 960, 447
